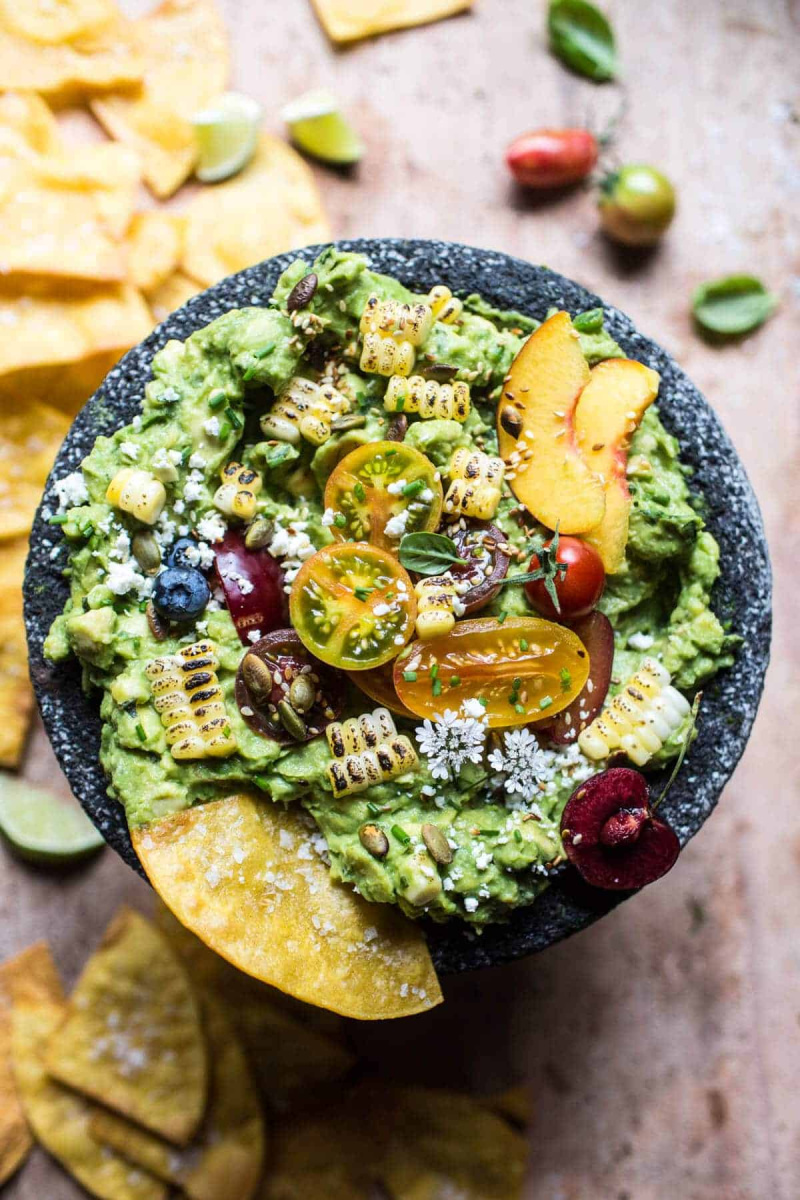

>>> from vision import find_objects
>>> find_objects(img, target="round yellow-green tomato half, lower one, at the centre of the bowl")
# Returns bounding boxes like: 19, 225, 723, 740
289, 541, 416, 671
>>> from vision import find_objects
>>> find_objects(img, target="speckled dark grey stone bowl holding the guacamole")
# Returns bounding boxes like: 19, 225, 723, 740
25, 239, 771, 972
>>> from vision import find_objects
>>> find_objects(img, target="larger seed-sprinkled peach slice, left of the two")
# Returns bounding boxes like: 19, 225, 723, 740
498, 312, 606, 533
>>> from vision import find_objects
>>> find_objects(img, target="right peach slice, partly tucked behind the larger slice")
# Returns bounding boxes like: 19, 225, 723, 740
575, 359, 661, 575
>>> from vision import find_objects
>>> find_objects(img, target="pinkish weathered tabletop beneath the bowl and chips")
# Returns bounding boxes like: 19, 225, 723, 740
0, 0, 800, 1200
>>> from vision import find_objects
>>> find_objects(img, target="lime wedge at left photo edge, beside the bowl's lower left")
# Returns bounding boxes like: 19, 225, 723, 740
0, 775, 104, 863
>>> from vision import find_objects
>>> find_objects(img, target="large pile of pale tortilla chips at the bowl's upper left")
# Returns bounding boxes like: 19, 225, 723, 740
0, 0, 330, 768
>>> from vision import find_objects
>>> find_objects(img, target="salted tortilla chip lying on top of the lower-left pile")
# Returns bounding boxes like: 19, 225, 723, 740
47, 908, 207, 1145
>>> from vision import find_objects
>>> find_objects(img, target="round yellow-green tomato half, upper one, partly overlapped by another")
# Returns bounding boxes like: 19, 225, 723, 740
325, 442, 443, 553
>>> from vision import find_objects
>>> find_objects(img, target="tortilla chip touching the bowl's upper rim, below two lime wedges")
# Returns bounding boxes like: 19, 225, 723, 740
182, 133, 331, 287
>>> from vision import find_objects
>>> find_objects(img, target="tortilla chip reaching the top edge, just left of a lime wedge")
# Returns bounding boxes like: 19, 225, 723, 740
91, 0, 230, 199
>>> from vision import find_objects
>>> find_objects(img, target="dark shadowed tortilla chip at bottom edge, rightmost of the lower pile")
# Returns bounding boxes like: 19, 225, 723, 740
379, 1087, 529, 1200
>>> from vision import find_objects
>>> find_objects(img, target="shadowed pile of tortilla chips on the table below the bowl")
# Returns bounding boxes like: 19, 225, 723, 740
0, 908, 528, 1200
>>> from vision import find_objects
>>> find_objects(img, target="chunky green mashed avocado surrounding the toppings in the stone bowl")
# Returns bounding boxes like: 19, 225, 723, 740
46, 250, 735, 926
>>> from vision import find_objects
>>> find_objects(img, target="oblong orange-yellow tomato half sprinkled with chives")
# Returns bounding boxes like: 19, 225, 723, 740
395, 617, 589, 728
